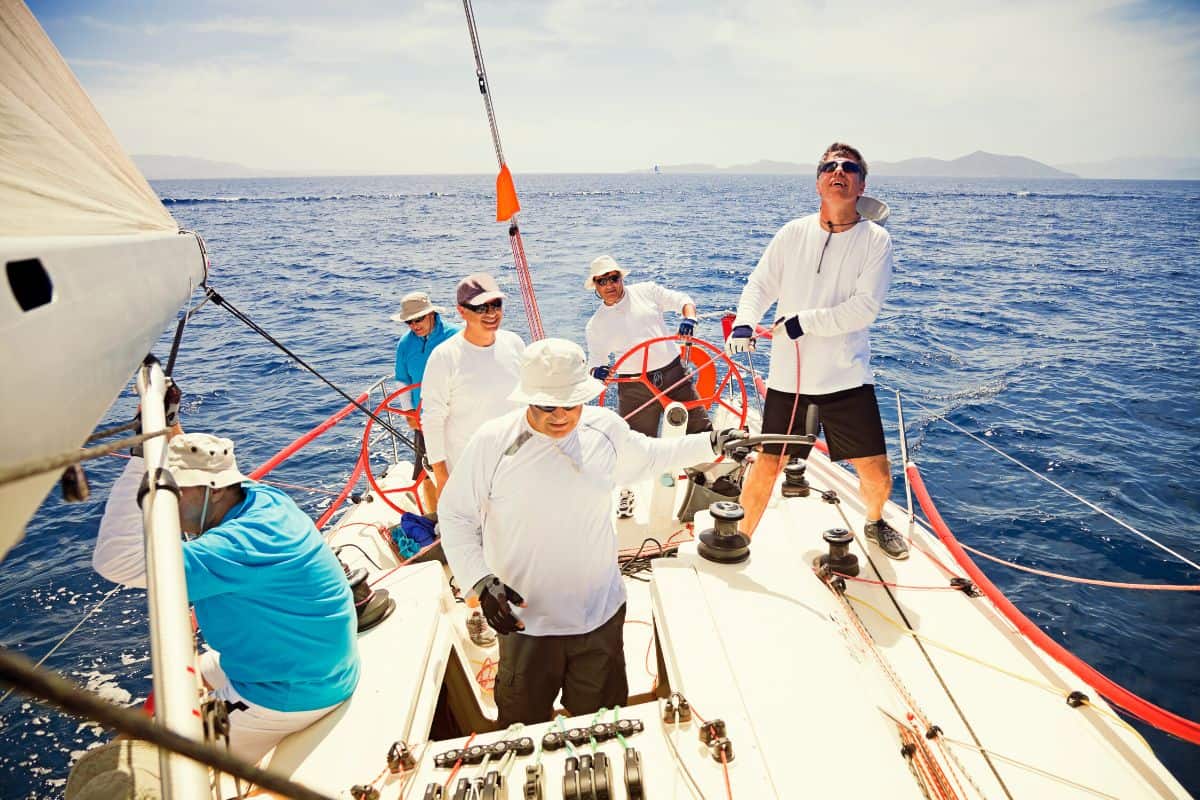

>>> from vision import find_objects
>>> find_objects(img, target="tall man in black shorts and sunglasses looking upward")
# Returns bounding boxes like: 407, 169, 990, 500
726, 142, 908, 559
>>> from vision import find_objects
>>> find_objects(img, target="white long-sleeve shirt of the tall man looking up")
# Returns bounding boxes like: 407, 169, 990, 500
733, 213, 892, 395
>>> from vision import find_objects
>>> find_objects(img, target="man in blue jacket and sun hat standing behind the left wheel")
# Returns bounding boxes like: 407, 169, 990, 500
391, 291, 462, 513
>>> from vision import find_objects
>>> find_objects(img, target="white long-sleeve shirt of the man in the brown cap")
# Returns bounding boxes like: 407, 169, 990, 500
421, 331, 524, 469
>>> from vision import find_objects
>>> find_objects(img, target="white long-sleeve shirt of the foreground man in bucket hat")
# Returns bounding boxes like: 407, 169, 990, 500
438, 405, 713, 636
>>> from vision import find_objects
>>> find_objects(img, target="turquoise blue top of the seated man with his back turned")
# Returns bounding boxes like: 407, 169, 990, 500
184, 482, 359, 711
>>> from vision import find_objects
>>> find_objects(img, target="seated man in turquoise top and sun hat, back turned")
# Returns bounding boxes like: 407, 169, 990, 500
92, 428, 359, 763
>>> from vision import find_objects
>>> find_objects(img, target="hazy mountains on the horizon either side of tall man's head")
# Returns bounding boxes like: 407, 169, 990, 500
637, 150, 1078, 178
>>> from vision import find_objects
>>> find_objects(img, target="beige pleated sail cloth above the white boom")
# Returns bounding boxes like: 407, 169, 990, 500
0, 0, 179, 236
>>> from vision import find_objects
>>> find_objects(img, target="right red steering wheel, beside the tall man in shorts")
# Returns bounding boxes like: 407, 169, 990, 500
600, 336, 748, 427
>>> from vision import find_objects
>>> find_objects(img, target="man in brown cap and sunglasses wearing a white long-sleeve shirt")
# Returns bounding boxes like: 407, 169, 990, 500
421, 272, 524, 492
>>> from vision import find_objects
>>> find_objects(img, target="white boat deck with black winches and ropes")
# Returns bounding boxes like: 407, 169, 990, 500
253, 453, 1188, 800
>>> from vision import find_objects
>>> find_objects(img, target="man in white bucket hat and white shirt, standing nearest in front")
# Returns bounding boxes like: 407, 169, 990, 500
439, 338, 730, 727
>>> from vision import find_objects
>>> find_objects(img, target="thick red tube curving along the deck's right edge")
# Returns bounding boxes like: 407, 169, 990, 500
905, 464, 1200, 745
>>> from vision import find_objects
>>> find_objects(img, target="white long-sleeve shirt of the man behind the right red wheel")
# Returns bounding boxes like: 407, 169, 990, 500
587, 283, 696, 373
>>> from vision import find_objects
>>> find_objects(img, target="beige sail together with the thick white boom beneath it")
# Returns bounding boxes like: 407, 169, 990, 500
0, 0, 205, 557
